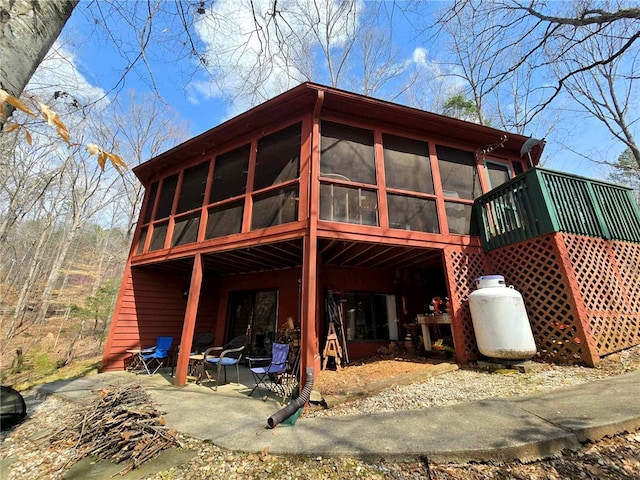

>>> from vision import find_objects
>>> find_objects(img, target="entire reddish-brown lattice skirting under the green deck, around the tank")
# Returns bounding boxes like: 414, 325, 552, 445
444, 233, 640, 366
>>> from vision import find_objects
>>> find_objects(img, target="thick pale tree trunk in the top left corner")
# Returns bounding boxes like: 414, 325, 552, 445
0, 0, 79, 122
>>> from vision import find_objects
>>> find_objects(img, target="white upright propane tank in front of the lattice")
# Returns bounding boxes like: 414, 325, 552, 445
469, 275, 536, 360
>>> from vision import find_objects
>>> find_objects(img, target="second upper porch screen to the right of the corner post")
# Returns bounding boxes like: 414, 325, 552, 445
382, 135, 433, 193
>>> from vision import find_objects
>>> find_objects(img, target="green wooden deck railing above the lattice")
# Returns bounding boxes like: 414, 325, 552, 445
475, 168, 640, 251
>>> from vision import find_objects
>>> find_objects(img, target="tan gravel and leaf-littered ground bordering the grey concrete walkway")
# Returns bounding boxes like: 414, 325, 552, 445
0, 347, 640, 480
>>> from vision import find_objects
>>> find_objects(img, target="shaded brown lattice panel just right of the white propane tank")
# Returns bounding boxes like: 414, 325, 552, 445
489, 235, 593, 364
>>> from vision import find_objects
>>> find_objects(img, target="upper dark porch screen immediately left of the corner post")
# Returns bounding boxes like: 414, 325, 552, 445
253, 124, 301, 190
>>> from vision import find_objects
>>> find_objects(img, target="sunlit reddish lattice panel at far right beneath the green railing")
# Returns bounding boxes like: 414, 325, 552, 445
561, 234, 640, 355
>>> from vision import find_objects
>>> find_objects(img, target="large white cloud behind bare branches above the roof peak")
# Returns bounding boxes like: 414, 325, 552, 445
190, 0, 363, 116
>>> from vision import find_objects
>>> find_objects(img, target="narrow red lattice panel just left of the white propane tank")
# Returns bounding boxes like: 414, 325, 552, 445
444, 247, 487, 364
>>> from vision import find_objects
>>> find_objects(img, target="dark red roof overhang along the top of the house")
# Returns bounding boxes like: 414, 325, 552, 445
133, 82, 542, 185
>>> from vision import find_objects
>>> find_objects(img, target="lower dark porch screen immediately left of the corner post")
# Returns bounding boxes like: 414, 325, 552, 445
251, 185, 298, 230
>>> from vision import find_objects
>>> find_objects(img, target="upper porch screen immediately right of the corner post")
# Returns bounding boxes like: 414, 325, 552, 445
320, 122, 376, 184
